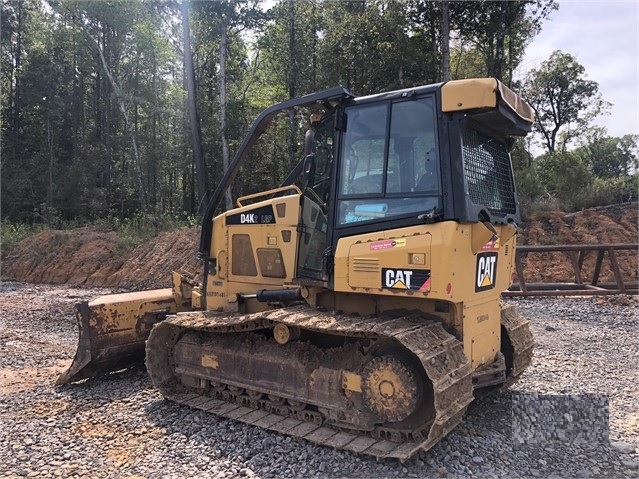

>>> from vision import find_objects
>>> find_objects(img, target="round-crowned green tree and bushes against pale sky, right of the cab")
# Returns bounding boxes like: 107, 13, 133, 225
512, 51, 639, 214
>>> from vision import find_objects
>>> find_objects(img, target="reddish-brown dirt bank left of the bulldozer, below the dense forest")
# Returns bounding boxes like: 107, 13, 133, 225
2, 226, 202, 289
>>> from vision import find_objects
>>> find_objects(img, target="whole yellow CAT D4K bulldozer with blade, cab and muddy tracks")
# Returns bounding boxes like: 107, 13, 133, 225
57, 78, 533, 460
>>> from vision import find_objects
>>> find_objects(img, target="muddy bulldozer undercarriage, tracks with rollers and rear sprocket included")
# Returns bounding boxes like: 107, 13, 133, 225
147, 307, 532, 460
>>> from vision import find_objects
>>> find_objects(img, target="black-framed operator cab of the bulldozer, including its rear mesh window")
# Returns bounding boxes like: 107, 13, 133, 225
297, 82, 529, 286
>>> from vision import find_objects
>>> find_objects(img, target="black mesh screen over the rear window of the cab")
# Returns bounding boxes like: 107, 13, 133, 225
463, 129, 516, 214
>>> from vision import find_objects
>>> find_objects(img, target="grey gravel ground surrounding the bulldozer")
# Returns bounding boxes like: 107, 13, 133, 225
0, 283, 639, 478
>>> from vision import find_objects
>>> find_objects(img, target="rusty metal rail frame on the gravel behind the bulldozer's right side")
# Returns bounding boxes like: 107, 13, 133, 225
502, 243, 639, 296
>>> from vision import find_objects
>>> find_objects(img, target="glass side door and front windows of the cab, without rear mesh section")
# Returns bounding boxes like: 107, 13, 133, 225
298, 94, 442, 281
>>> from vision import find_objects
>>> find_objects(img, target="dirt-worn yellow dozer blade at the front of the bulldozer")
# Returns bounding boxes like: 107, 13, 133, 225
56, 288, 182, 385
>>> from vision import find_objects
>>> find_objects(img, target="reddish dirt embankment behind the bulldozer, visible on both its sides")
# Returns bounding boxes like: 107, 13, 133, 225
2, 203, 638, 290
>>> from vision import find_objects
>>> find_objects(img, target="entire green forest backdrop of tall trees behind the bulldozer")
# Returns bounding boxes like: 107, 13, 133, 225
0, 0, 639, 247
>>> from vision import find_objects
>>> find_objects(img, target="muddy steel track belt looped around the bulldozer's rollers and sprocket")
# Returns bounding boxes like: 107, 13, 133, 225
147, 307, 527, 461
